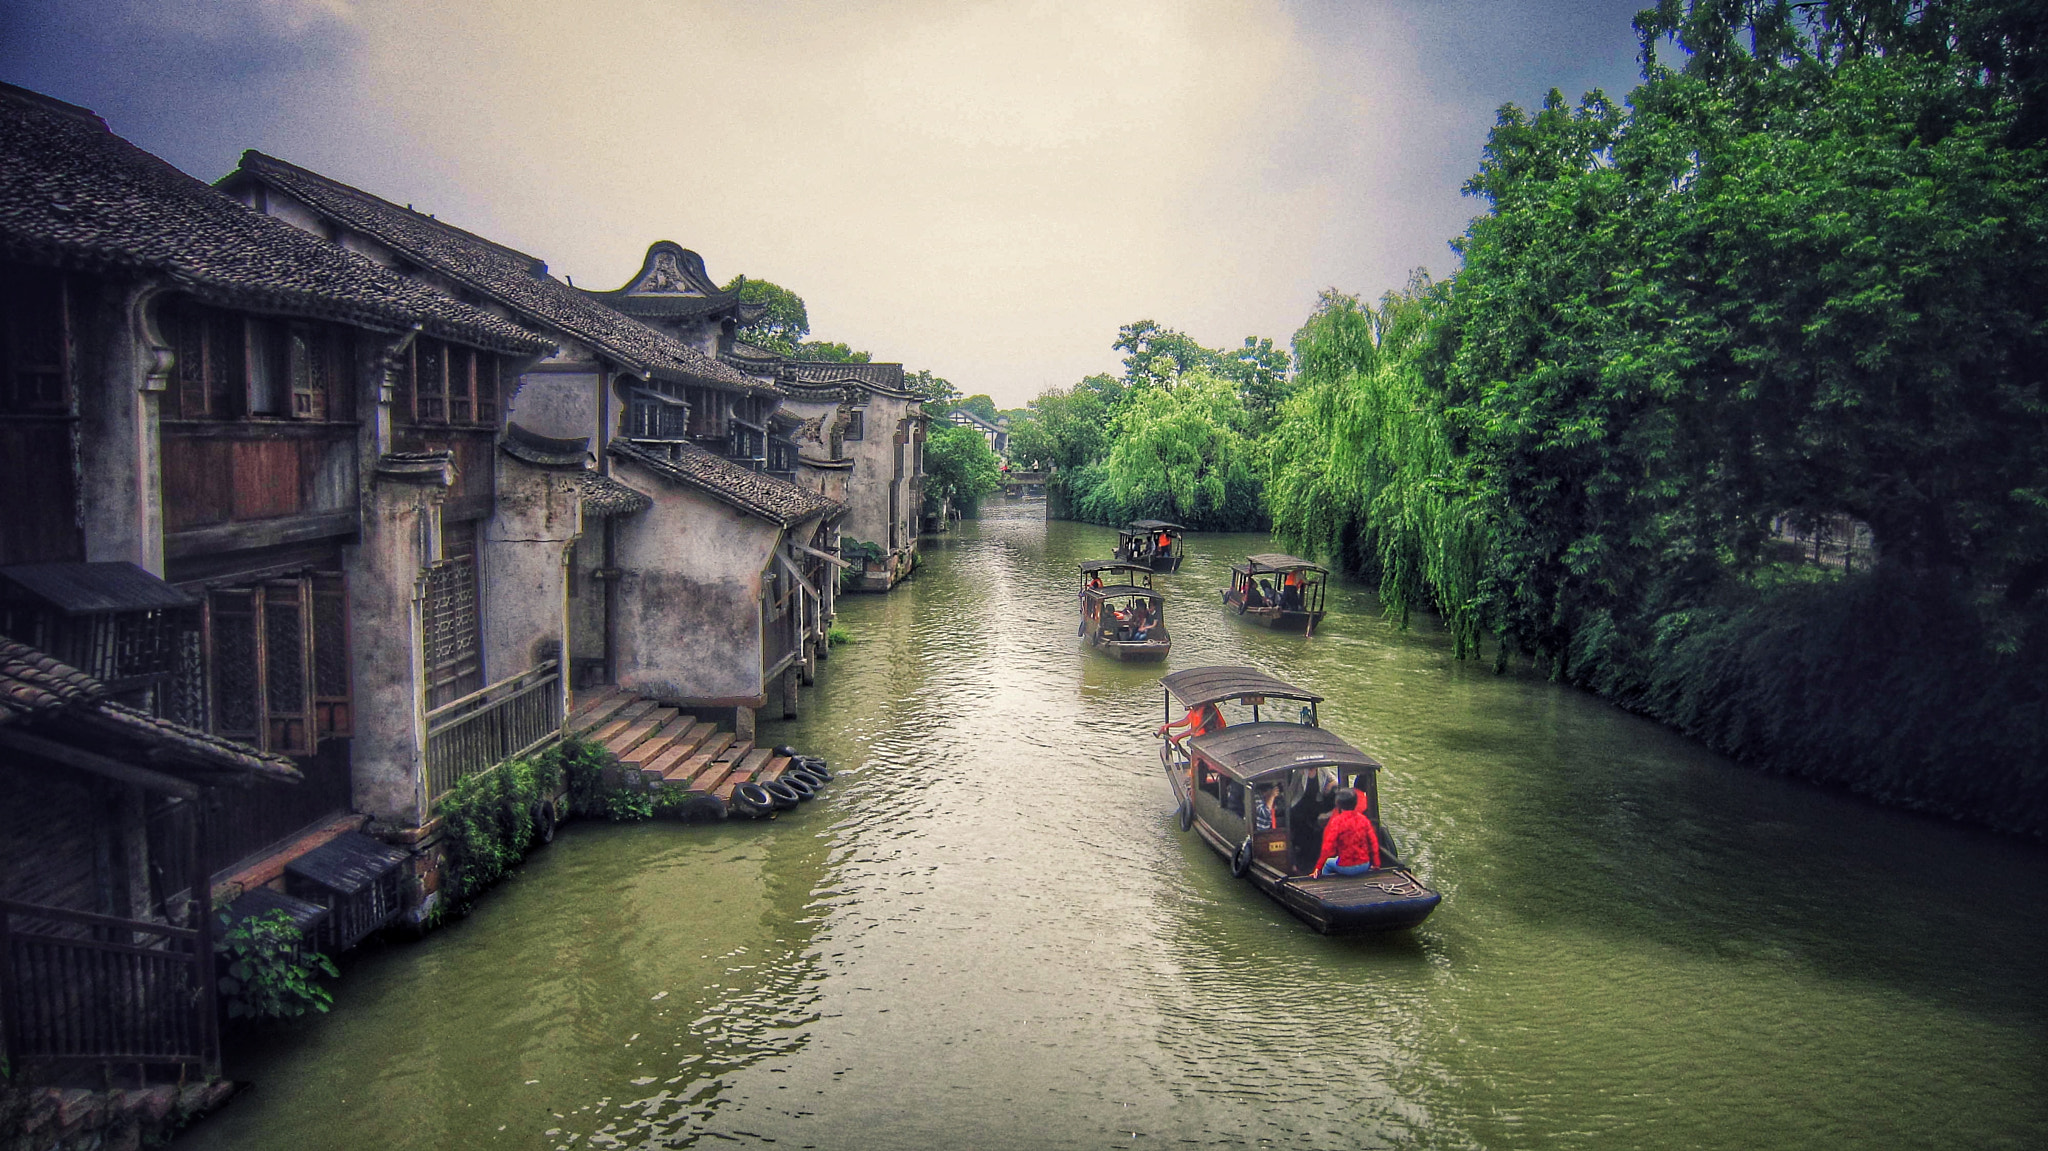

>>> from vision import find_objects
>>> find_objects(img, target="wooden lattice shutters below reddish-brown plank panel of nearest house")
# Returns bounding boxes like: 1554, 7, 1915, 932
207, 573, 352, 756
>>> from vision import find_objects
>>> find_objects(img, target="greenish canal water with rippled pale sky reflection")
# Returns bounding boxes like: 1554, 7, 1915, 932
180, 504, 2048, 1151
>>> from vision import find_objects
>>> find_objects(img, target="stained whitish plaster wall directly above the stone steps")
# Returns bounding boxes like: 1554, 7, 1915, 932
614, 459, 782, 707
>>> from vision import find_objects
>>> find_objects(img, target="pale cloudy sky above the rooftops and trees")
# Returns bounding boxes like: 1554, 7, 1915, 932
0, 0, 1647, 408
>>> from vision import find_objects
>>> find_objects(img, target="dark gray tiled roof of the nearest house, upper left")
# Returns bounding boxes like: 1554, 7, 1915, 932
0, 84, 551, 352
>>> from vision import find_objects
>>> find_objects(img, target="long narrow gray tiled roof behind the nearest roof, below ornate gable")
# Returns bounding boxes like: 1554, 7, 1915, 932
221, 152, 766, 391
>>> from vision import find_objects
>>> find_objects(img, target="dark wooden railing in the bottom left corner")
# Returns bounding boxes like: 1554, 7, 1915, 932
0, 899, 219, 1071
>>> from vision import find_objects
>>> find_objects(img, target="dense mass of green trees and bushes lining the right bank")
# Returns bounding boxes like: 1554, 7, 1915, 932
1012, 0, 2048, 838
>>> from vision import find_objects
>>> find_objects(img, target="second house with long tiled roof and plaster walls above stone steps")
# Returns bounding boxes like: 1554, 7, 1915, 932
221, 165, 840, 737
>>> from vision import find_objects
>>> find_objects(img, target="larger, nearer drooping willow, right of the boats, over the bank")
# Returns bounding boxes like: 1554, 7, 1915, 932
1266, 276, 1491, 657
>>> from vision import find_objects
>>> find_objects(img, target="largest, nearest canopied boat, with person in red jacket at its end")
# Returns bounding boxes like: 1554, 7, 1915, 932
1159, 666, 1444, 934
